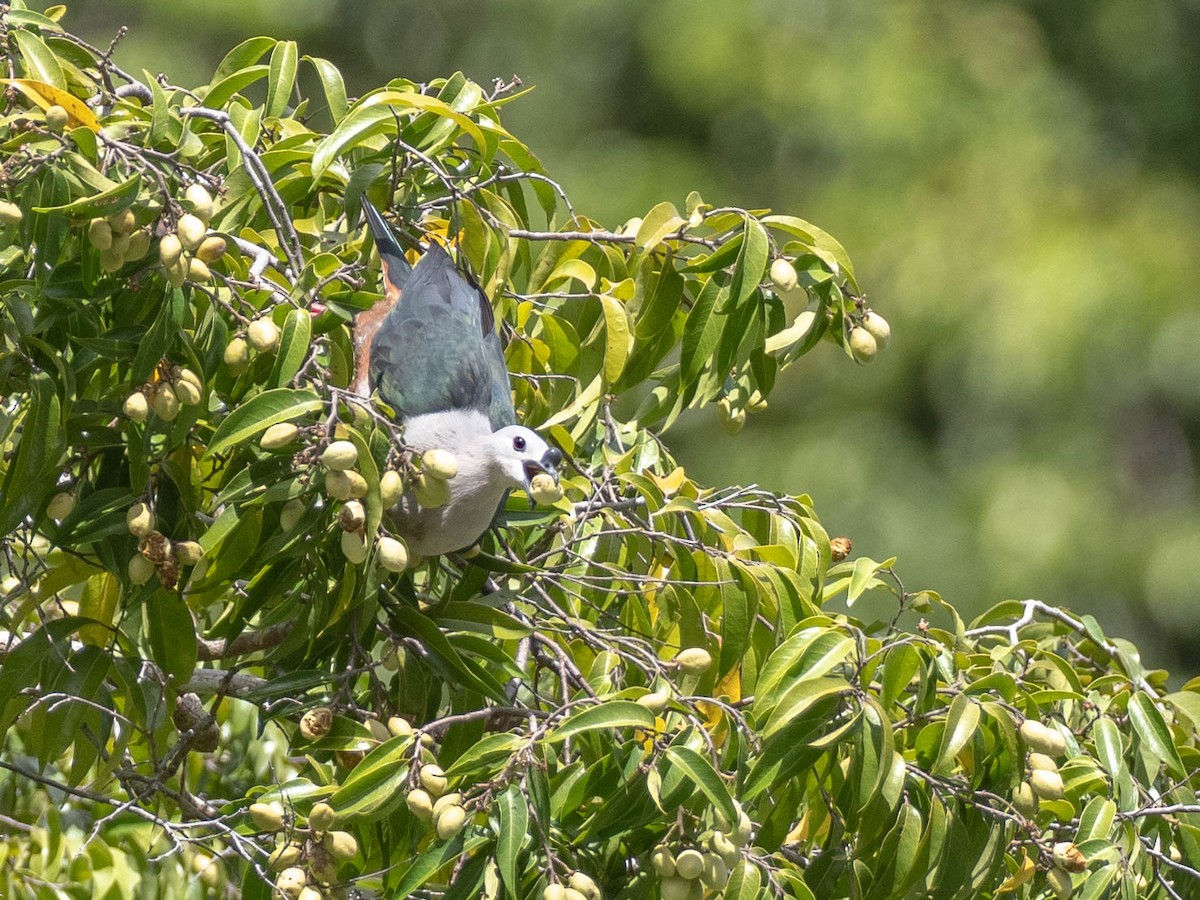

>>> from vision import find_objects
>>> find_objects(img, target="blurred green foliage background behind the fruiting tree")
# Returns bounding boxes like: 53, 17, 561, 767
67, 0, 1200, 676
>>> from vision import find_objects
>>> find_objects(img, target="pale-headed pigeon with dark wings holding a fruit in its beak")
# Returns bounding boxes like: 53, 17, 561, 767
355, 198, 563, 556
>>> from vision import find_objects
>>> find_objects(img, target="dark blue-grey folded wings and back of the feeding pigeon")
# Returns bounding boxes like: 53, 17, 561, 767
370, 245, 516, 428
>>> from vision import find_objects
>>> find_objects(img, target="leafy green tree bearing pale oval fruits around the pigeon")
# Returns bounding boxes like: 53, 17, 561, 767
0, 4, 1200, 900
